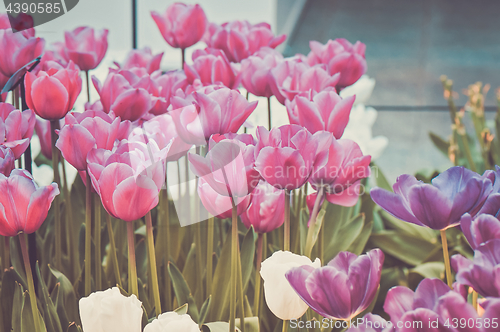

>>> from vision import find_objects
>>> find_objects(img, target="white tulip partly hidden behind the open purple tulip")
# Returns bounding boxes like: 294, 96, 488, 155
260, 250, 321, 320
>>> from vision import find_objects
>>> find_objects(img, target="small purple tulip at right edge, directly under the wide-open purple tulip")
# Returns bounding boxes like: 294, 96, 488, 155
460, 213, 500, 250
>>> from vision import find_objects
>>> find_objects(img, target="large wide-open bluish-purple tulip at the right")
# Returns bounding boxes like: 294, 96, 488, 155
370, 166, 494, 230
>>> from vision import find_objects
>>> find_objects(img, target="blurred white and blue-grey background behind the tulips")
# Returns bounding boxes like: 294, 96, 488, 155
24, 0, 500, 183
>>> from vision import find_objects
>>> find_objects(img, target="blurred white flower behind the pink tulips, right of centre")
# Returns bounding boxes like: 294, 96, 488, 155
340, 104, 389, 160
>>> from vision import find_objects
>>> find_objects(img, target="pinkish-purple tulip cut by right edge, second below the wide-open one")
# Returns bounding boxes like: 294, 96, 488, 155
451, 239, 500, 297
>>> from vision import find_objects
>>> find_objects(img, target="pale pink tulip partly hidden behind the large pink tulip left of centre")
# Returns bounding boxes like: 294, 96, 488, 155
128, 113, 191, 161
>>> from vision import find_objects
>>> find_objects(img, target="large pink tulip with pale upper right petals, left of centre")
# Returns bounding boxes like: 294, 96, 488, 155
87, 141, 168, 221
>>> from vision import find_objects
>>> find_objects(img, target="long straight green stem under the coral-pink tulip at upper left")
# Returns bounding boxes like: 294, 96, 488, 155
50, 120, 62, 270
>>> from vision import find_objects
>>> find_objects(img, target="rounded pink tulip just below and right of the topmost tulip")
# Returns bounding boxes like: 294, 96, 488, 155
184, 48, 240, 89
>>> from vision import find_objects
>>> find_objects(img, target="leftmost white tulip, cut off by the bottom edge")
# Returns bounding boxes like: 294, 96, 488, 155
79, 287, 143, 332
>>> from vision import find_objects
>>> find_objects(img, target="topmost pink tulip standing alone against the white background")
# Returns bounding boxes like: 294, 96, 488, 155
151, 2, 208, 49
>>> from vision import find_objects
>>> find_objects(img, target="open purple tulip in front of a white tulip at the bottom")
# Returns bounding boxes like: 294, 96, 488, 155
286, 249, 384, 320
